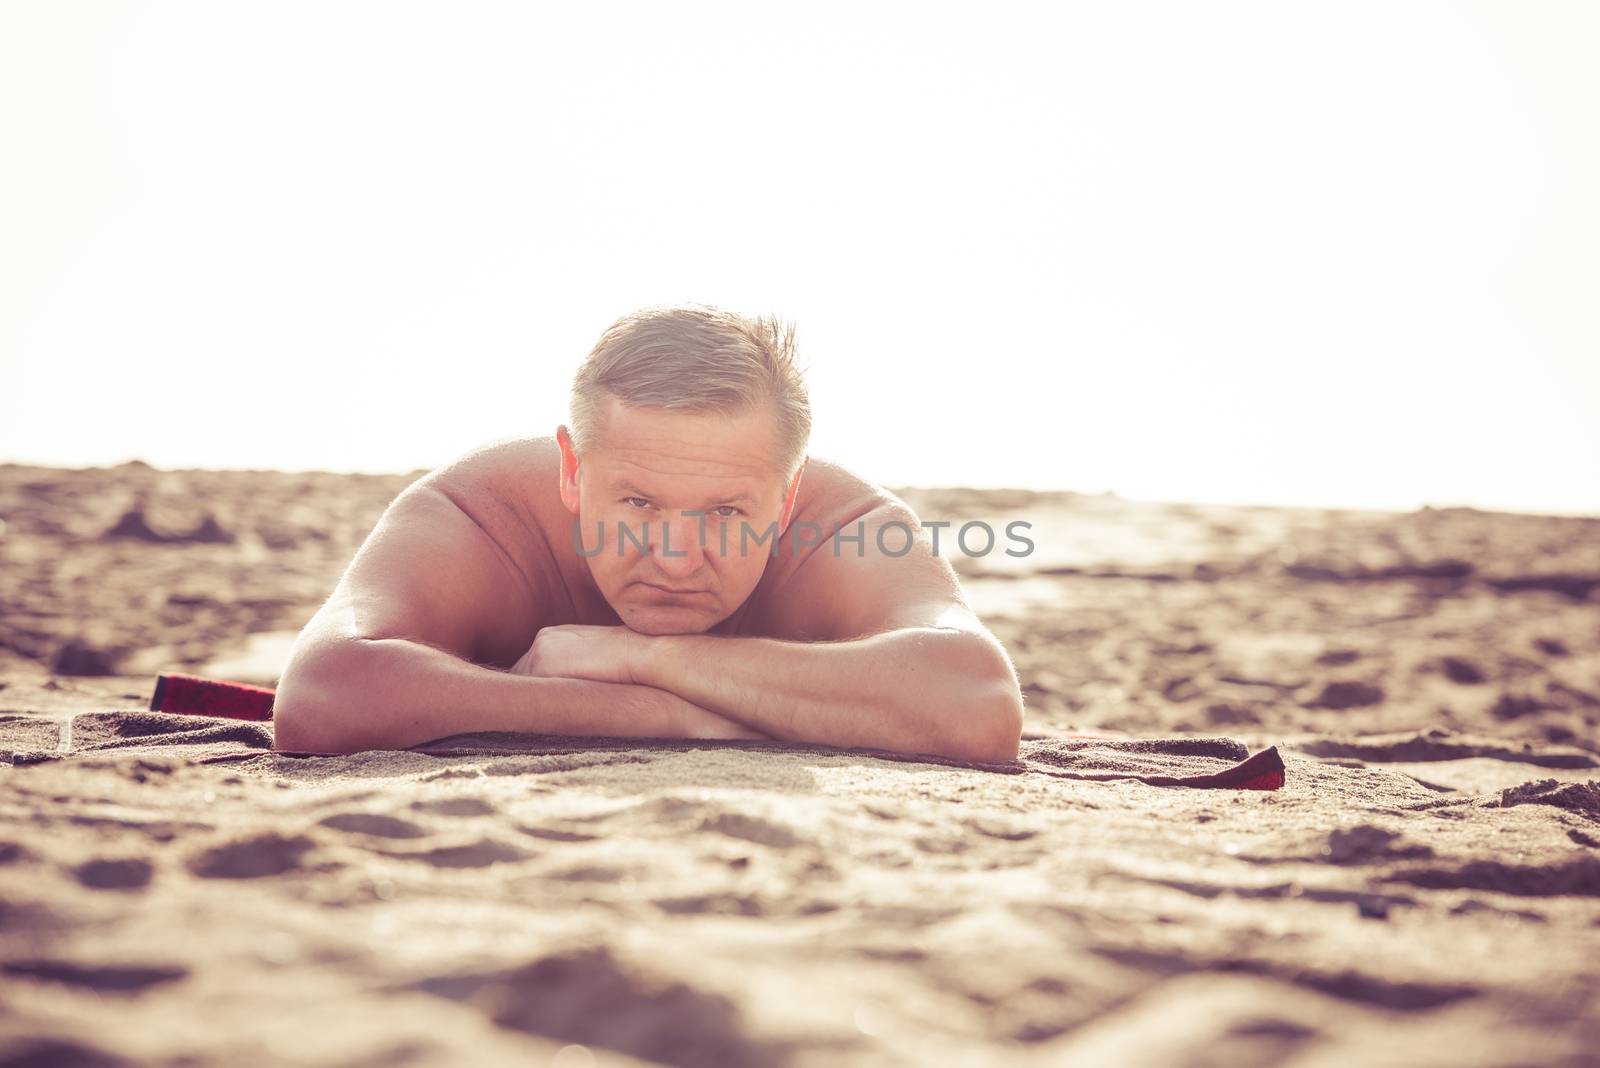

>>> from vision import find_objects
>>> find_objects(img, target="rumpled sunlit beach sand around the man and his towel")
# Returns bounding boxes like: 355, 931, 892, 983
0, 465, 1600, 1068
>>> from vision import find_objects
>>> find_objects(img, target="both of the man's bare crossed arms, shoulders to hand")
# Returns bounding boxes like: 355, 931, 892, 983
274, 483, 1022, 761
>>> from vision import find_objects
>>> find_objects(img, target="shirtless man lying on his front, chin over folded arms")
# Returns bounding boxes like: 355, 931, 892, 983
274, 305, 1022, 761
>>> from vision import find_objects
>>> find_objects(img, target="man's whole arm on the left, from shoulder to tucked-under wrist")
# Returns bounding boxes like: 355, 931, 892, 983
274, 483, 766, 753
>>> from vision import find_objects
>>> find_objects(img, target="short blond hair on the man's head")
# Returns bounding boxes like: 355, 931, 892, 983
568, 304, 811, 478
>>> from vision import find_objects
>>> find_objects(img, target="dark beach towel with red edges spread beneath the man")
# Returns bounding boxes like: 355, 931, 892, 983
131, 673, 1283, 790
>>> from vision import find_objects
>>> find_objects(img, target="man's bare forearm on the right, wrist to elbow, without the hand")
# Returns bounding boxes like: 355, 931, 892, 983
634, 627, 1022, 761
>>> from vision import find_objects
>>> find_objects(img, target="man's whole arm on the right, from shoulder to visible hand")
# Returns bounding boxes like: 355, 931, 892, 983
515, 505, 1022, 761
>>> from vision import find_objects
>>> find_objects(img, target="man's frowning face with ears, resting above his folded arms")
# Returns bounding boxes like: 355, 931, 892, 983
557, 398, 800, 635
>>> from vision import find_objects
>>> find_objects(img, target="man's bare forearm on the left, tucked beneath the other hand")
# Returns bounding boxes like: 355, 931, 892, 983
274, 640, 731, 753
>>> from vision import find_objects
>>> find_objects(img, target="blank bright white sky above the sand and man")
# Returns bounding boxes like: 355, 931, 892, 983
0, 0, 1600, 513
